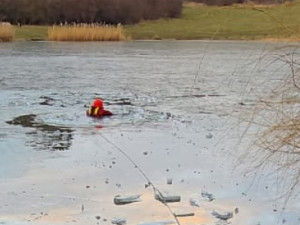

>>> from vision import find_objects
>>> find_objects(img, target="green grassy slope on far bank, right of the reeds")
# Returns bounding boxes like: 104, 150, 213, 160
125, 0, 300, 40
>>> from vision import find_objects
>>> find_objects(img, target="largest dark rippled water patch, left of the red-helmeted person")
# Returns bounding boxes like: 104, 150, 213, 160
7, 114, 73, 151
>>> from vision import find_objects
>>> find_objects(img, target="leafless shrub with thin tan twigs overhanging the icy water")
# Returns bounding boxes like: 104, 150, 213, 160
240, 46, 300, 200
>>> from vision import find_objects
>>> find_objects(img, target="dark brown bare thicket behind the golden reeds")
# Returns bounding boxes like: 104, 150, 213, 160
0, 0, 183, 24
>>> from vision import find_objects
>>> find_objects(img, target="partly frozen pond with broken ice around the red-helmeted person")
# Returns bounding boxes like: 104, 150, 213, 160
0, 41, 300, 225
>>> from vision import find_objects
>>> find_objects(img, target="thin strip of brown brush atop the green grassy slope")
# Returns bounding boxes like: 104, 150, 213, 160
187, 0, 293, 6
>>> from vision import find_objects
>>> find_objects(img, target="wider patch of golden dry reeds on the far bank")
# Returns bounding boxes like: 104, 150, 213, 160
48, 25, 125, 41
